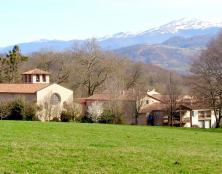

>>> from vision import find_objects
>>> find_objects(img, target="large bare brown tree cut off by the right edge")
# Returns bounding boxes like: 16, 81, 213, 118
190, 32, 222, 127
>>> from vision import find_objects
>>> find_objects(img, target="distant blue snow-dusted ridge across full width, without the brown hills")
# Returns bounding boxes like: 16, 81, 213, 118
0, 18, 222, 53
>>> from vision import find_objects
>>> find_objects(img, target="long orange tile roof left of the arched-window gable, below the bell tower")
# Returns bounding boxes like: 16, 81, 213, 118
0, 83, 50, 94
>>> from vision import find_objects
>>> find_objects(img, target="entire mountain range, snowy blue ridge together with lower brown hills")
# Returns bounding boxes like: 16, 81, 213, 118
0, 18, 222, 71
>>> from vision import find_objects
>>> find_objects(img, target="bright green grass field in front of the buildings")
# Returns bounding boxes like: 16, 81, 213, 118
0, 121, 222, 174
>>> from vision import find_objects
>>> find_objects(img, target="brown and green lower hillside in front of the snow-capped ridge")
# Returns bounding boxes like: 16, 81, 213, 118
114, 44, 201, 73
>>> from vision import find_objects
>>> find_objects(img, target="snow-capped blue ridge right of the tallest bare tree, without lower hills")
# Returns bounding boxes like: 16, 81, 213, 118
99, 18, 222, 49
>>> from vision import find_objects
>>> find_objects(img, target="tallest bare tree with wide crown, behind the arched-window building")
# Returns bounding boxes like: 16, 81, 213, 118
71, 38, 123, 96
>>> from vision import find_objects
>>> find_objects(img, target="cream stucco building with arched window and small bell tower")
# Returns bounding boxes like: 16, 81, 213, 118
0, 69, 73, 121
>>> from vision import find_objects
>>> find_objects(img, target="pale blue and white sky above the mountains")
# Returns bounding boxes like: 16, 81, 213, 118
0, 0, 222, 47
